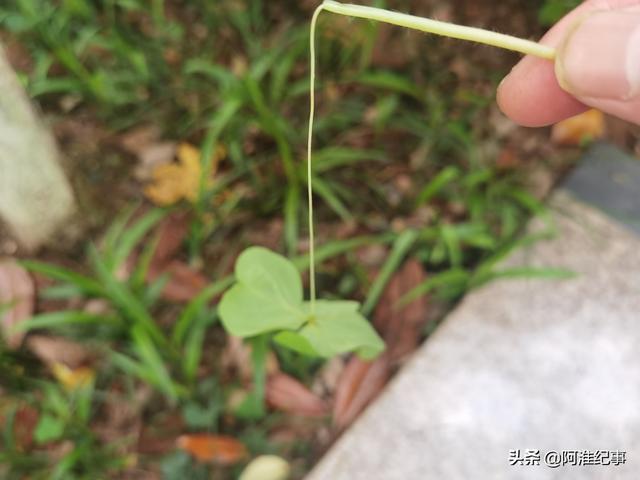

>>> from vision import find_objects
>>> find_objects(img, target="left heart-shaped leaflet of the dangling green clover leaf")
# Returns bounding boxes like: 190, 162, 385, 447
219, 247, 307, 337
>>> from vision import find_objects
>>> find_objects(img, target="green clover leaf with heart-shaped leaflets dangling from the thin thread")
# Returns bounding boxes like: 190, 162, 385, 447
219, 247, 384, 359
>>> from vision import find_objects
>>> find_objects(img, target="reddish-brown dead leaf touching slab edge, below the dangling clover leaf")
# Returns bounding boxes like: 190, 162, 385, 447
333, 354, 391, 430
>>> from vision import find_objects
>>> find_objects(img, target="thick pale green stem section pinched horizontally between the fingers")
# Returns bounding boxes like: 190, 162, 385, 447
322, 0, 556, 60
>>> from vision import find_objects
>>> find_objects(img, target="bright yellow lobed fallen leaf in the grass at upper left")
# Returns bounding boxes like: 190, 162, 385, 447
144, 143, 226, 206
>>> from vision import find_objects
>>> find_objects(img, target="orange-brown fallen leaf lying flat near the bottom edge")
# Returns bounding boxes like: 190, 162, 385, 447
176, 433, 247, 465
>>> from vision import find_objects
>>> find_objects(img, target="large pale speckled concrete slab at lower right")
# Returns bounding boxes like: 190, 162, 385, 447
307, 192, 640, 480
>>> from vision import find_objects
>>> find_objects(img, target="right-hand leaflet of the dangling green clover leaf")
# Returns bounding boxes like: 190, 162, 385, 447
299, 300, 384, 359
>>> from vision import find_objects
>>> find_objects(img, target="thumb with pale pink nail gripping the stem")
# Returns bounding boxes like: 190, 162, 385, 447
556, 10, 640, 123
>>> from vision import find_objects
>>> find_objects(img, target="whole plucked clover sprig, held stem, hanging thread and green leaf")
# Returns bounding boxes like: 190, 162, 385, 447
219, 0, 556, 412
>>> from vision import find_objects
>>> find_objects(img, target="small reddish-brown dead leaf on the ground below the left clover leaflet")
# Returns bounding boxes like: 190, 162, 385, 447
265, 373, 327, 417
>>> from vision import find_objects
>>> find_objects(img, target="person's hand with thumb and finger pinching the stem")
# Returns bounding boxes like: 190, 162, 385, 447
498, 0, 640, 127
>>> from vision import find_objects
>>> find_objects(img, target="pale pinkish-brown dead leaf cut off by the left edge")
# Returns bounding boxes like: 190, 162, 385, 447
0, 259, 35, 348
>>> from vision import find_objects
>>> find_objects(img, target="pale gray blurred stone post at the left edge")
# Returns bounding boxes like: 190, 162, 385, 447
0, 47, 75, 250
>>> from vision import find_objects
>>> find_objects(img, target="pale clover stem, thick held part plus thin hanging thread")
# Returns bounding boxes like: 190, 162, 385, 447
307, 0, 556, 312
